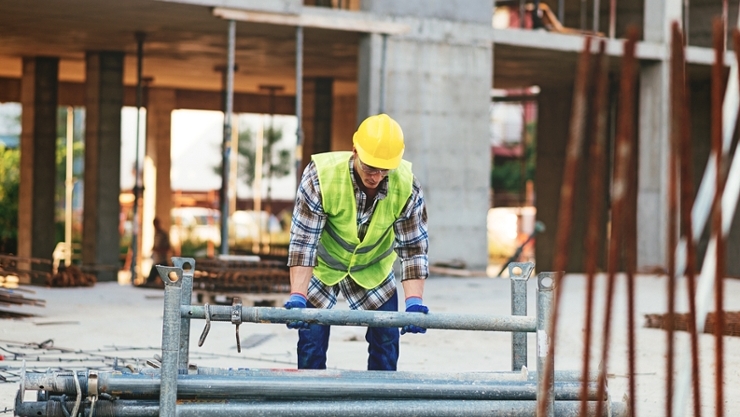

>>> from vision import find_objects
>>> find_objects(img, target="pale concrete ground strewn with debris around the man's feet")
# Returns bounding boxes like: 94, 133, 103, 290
0, 275, 740, 416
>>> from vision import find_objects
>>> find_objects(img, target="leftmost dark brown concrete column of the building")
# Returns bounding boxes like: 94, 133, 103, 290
18, 57, 59, 284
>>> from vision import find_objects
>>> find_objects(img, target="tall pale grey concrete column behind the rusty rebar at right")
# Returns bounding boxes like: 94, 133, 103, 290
637, 0, 681, 269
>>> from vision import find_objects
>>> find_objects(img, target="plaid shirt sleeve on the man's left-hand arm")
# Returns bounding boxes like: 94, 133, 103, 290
288, 162, 326, 266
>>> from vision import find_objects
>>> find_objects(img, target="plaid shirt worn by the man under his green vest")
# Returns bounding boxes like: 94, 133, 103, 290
288, 154, 429, 310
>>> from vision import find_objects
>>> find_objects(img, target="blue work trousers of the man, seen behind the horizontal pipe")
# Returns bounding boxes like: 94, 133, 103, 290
298, 293, 399, 371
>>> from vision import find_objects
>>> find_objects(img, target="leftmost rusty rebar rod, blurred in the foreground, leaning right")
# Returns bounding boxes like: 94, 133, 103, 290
537, 37, 591, 417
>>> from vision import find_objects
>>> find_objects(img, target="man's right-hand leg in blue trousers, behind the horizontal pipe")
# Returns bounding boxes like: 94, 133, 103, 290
365, 293, 399, 371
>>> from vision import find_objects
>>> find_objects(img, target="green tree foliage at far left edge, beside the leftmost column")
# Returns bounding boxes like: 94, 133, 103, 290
0, 142, 21, 253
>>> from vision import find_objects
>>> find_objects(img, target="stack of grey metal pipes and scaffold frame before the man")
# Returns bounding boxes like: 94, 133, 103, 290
15, 258, 629, 417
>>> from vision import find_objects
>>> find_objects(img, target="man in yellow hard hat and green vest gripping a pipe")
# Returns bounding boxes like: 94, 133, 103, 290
285, 114, 429, 371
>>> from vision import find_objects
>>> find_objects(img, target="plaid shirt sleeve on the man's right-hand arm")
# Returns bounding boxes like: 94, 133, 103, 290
393, 177, 429, 281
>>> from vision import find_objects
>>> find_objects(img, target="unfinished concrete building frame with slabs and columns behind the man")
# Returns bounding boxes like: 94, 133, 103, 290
0, 0, 740, 281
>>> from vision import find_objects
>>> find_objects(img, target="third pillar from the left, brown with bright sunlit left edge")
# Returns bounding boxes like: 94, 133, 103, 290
139, 88, 174, 276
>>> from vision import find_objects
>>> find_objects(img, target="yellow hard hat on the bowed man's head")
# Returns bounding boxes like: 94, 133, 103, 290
352, 114, 404, 169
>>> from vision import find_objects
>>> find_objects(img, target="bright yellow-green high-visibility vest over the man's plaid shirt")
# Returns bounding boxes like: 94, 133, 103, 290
311, 152, 414, 289
